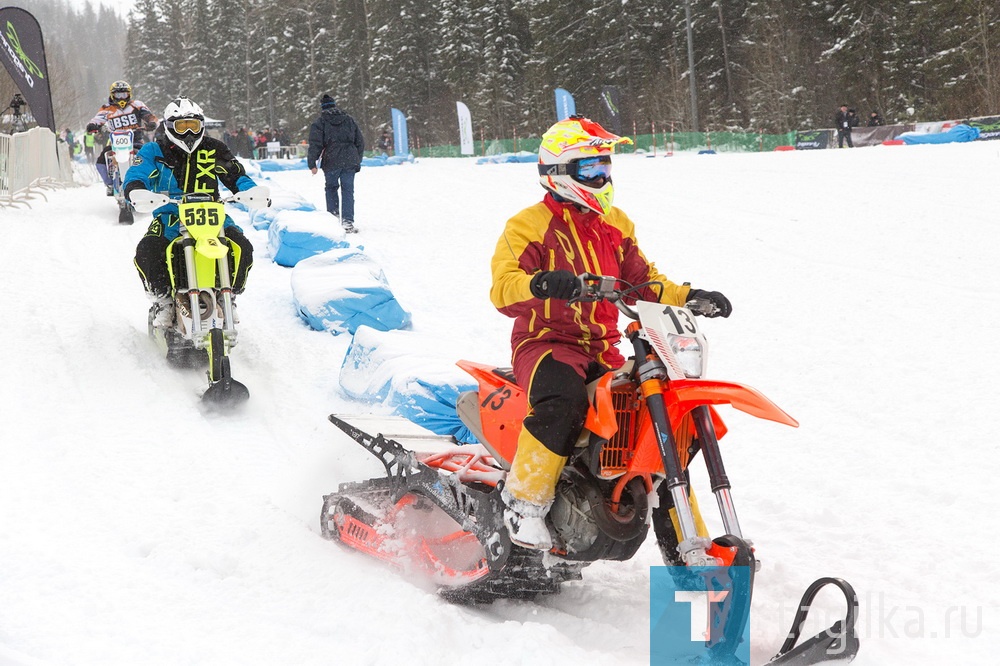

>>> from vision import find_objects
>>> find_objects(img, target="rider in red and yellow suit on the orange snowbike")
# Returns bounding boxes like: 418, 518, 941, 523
490, 116, 732, 550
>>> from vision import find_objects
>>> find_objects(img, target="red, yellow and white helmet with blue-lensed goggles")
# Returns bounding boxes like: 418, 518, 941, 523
538, 116, 632, 215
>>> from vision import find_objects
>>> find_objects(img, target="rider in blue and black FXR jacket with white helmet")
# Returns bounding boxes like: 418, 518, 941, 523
124, 97, 257, 326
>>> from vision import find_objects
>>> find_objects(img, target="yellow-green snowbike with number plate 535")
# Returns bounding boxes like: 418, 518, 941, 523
131, 186, 270, 405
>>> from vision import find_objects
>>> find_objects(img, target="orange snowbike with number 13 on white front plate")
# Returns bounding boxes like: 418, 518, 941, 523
321, 274, 853, 663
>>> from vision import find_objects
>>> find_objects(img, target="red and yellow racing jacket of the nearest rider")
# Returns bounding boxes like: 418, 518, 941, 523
490, 194, 690, 381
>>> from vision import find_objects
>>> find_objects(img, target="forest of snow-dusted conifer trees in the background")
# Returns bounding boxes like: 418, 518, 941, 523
7, 0, 1000, 145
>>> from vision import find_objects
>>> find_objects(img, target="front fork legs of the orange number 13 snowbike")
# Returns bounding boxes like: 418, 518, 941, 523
628, 328, 743, 566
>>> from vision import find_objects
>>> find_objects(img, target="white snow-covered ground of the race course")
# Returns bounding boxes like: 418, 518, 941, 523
0, 142, 1000, 666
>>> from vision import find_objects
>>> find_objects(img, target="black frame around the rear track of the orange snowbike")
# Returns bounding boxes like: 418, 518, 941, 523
320, 414, 583, 603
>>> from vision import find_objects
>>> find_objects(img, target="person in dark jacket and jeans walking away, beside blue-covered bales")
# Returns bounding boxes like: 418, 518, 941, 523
307, 95, 365, 233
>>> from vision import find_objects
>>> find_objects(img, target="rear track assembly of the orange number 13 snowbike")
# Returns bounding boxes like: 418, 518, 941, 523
320, 415, 583, 603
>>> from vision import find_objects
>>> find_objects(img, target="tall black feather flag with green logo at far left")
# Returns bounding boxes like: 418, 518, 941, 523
0, 7, 56, 132
